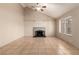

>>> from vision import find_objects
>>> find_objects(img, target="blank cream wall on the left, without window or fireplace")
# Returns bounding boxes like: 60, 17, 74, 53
0, 4, 24, 47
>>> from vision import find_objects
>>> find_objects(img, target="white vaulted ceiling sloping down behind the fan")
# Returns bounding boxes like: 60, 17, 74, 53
21, 3, 79, 18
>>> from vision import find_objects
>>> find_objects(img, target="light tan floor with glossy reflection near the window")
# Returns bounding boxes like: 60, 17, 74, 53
0, 37, 79, 55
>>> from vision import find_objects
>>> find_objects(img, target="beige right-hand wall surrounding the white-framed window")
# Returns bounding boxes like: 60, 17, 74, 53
56, 6, 79, 48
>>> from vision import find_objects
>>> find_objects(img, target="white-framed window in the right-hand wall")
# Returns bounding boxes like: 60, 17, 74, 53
59, 16, 72, 35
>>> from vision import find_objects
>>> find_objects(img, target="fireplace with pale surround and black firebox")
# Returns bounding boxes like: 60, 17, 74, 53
33, 27, 46, 37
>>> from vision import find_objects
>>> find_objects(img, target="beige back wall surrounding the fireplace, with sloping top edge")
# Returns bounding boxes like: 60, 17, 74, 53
24, 8, 55, 36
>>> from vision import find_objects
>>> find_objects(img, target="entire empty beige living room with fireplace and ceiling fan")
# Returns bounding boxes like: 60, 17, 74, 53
0, 3, 79, 55
